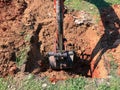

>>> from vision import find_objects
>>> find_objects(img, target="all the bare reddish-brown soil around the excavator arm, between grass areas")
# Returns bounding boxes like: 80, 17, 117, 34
0, 0, 120, 81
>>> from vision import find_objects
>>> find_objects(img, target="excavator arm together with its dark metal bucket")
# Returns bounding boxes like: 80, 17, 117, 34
48, 0, 74, 69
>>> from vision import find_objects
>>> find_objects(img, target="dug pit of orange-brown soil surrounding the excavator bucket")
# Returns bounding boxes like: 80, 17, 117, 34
25, 12, 109, 81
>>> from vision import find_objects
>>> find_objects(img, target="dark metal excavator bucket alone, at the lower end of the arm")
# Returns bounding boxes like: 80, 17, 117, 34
49, 51, 74, 69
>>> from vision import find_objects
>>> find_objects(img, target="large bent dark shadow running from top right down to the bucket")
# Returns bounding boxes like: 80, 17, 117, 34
68, 0, 120, 77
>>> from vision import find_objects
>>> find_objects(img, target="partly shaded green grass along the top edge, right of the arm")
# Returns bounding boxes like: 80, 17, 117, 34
65, 0, 120, 22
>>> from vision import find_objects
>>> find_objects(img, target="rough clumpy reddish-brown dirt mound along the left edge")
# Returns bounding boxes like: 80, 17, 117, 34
0, 0, 27, 76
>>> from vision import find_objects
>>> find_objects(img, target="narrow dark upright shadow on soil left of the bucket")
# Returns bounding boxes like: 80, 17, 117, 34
25, 24, 42, 72
